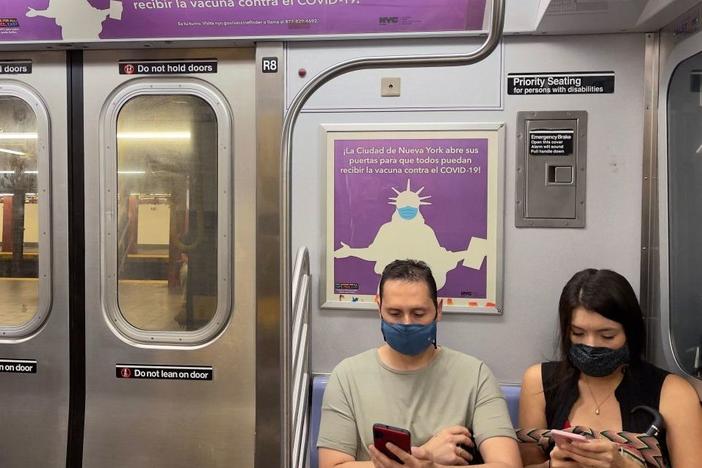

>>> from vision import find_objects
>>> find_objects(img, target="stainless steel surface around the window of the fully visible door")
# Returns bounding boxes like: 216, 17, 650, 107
83, 49, 256, 468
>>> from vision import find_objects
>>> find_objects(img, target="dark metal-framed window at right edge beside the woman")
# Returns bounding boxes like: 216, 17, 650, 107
657, 41, 702, 401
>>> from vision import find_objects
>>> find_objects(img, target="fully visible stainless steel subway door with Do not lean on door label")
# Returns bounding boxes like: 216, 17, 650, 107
83, 48, 256, 468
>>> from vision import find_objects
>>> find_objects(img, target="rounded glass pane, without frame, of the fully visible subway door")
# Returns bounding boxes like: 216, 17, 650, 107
117, 95, 218, 331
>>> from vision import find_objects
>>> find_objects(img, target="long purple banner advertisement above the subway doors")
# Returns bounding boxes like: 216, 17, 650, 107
0, 0, 486, 42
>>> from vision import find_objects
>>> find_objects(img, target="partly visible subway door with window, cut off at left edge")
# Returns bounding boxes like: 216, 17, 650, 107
0, 52, 69, 468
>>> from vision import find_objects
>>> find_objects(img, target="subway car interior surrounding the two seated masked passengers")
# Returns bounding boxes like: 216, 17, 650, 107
0, 0, 702, 468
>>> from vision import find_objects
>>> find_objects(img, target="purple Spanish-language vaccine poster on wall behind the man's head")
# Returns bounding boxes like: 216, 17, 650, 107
327, 132, 496, 306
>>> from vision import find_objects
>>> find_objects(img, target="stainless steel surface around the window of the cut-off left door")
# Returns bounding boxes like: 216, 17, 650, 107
0, 52, 69, 468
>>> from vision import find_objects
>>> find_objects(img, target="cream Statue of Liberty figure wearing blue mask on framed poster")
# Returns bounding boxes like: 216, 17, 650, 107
334, 179, 487, 289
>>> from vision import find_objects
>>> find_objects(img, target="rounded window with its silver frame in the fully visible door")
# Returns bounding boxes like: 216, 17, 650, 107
102, 79, 233, 344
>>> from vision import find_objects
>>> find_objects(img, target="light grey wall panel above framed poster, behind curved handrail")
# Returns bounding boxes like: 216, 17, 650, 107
286, 38, 504, 112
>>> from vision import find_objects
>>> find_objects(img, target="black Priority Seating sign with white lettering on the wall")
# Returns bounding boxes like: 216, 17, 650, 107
507, 71, 614, 96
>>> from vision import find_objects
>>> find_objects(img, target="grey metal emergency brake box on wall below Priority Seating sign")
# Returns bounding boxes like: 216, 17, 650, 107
514, 111, 587, 228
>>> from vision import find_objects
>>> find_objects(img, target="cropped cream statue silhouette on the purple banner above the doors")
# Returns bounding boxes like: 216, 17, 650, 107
27, 0, 123, 40
